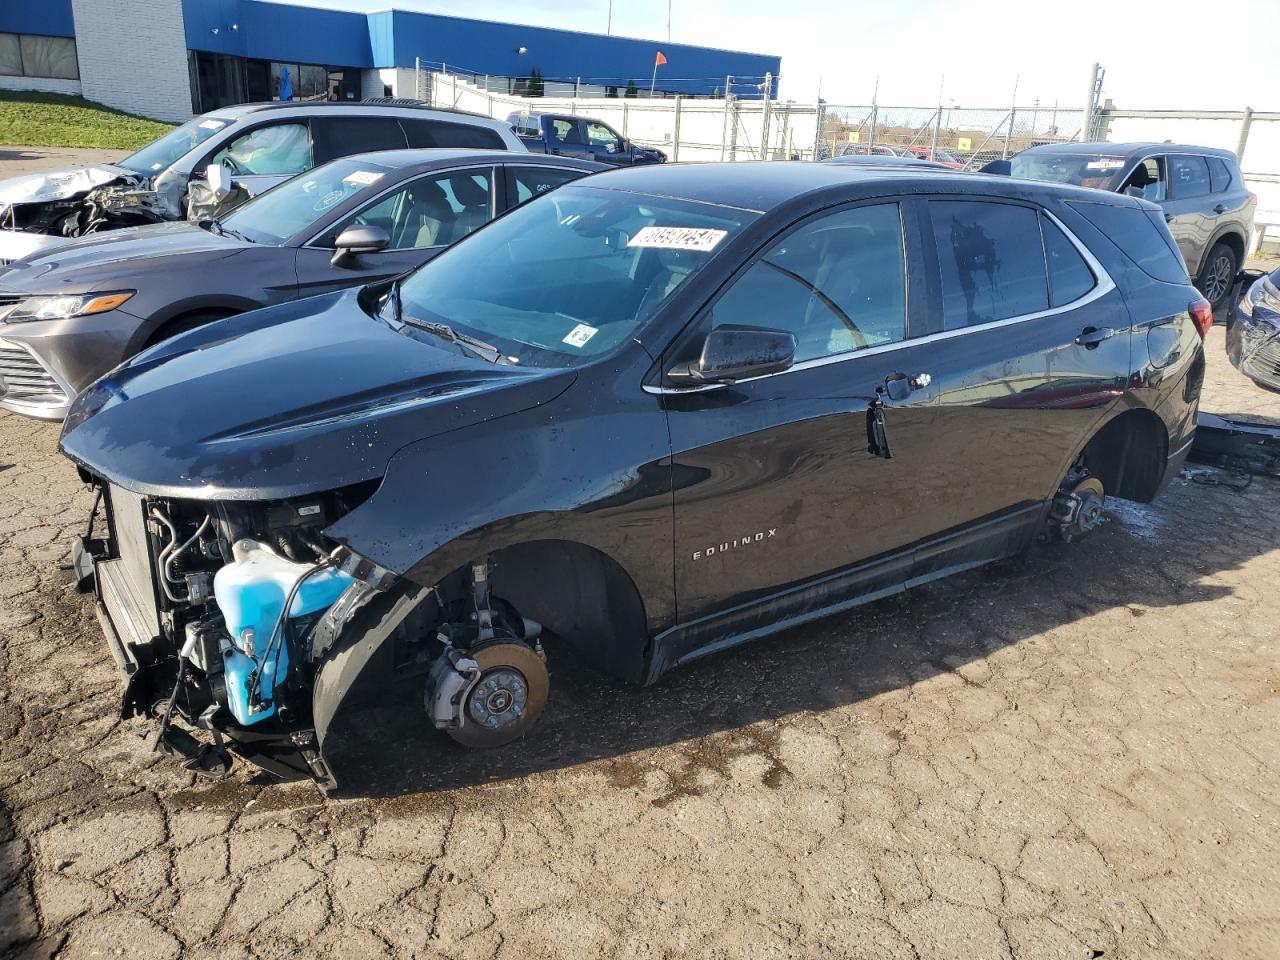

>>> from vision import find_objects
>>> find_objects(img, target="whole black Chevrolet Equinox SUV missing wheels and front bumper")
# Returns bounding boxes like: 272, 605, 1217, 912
61, 164, 1212, 785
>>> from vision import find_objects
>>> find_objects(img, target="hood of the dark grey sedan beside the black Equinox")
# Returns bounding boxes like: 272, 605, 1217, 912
0, 221, 245, 293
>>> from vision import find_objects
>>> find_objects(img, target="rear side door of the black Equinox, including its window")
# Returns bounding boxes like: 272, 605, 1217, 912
911, 198, 1132, 572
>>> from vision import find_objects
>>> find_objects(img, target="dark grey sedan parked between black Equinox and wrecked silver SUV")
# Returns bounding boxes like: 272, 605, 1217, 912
0, 150, 593, 419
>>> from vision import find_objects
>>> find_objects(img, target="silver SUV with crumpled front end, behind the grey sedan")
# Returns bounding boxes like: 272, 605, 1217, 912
0, 101, 525, 264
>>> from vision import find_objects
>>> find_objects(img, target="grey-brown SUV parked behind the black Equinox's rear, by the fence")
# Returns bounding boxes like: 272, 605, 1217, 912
992, 143, 1258, 310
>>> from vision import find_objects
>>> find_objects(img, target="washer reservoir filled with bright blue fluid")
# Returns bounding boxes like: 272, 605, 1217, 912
214, 540, 353, 726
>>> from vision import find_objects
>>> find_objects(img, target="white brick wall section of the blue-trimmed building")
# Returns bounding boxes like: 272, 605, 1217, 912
72, 0, 191, 120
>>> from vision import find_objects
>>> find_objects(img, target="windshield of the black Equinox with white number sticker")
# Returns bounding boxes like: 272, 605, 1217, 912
389, 187, 756, 366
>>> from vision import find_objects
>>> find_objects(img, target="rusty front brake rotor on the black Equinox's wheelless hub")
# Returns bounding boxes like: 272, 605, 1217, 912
445, 643, 550, 749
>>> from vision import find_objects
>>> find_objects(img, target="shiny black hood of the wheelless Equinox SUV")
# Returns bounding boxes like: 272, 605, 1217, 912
59, 291, 575, 499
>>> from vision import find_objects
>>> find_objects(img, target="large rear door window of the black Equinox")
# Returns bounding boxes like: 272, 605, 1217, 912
929, 200, 1048, 330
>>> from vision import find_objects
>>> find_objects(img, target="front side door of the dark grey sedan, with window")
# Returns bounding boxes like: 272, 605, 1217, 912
296, 165, 495, 297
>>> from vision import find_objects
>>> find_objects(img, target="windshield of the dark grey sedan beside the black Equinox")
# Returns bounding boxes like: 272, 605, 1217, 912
221, 159, 389, 243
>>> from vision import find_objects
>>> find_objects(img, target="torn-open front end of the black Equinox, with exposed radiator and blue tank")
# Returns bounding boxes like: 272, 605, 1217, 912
73, 477, 393, 787
